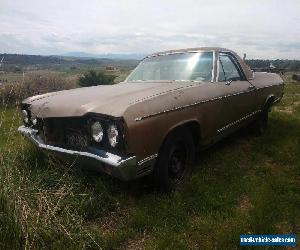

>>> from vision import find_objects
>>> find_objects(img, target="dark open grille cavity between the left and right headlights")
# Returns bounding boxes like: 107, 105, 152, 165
37, 117, 89, 151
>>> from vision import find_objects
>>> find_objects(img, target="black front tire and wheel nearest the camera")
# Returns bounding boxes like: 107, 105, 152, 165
154, 129, 195, 192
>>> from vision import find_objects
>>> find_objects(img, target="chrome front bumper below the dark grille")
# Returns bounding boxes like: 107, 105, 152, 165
18, 126, 138, 181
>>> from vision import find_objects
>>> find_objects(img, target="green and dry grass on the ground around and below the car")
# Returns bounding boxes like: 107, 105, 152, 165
0, 78, 300, 249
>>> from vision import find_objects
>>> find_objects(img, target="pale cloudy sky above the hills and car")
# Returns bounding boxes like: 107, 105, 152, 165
0, 0, 300, 59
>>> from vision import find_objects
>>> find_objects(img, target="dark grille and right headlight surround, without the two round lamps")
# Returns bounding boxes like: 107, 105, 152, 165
34, 114, 126, 155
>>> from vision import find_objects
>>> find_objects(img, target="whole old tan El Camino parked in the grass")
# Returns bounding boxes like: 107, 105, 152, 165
18, 48, 284, 190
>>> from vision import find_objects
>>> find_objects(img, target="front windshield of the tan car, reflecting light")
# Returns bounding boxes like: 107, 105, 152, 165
127, 52, 213, 81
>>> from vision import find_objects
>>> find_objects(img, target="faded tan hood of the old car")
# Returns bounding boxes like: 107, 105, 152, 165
23, 81, 199, 118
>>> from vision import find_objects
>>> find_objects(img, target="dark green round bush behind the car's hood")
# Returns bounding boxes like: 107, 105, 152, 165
78, 70, 116, 87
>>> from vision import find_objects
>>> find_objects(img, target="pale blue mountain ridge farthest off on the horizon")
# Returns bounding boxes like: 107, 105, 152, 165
61, 52, 145, 60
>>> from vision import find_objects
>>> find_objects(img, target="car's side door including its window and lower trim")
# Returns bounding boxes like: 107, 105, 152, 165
216, 53, 255, 133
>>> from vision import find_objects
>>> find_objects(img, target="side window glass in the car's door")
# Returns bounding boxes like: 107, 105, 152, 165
219, 54, 241, 82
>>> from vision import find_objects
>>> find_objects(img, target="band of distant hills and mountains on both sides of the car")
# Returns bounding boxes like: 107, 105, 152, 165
0, 52, 300, 71
